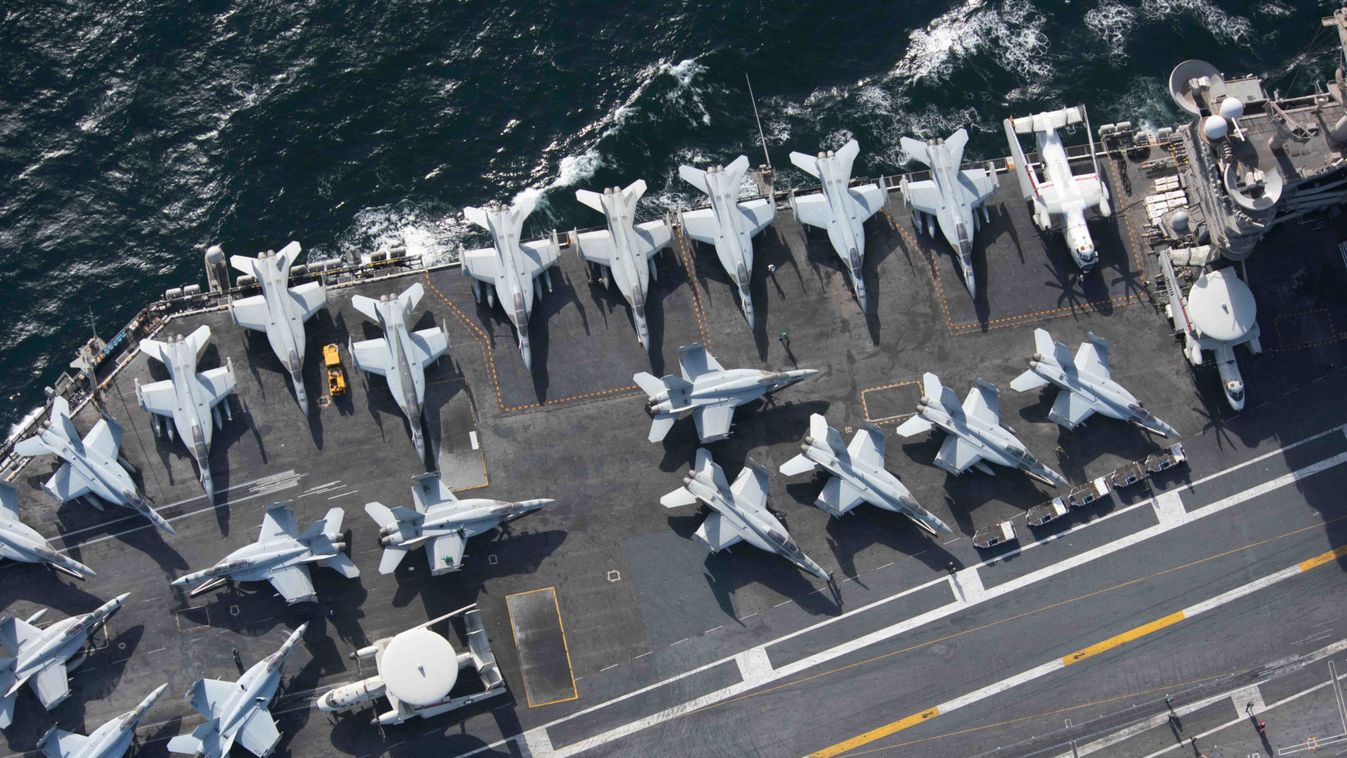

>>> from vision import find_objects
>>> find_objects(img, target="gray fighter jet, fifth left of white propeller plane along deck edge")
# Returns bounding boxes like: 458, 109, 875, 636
463, 193, 560, 370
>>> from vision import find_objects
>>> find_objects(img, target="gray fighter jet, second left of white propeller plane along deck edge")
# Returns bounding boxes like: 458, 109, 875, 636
791, 140, 889, 311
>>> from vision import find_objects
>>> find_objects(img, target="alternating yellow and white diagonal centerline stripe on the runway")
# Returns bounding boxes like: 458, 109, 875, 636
810, 545, 1347, 758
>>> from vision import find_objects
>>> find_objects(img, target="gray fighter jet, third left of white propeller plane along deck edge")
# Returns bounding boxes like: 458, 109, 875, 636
678, 155, 776, 329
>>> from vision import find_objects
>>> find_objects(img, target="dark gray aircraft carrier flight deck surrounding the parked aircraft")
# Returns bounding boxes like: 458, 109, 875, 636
0, 7, 1347, 757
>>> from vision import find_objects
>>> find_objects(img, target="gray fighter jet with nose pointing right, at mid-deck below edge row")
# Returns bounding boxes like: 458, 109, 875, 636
632, 343, 819, 443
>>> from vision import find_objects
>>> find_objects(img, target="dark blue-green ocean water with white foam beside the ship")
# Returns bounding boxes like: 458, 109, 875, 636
0, 0, 1336, 432
